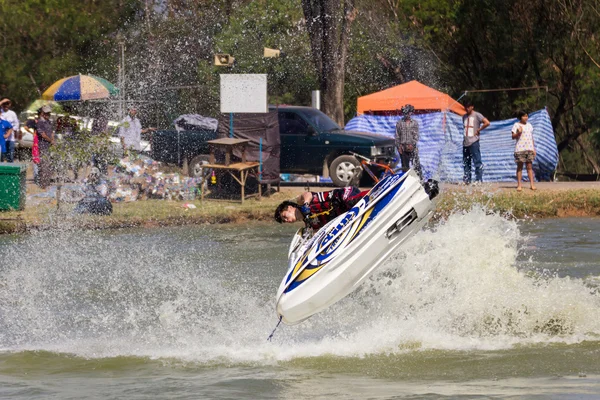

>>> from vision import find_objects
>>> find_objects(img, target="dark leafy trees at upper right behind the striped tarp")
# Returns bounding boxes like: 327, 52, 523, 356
390, 0, 600, 172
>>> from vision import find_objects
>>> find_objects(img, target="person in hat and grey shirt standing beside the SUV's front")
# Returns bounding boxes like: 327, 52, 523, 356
396, 104, 423, 180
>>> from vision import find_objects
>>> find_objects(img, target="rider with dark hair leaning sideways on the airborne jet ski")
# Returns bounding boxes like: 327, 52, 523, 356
275, 186, 368, 231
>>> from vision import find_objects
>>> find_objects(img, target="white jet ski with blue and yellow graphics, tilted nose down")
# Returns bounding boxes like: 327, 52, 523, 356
276, 170, 439, 325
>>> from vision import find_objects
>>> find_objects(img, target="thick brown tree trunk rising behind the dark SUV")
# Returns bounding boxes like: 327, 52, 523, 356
302, 0, 357, 125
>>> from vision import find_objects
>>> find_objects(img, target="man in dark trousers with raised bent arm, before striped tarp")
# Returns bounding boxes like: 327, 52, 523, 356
463, 103, 490, 185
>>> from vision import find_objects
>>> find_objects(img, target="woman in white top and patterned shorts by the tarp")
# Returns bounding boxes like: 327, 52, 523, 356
511, 111, 536, 192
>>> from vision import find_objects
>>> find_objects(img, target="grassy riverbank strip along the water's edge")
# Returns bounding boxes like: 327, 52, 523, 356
0, 182, 600, 234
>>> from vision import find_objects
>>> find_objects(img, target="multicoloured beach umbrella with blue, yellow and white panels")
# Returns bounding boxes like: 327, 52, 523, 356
42, 75, 119, 101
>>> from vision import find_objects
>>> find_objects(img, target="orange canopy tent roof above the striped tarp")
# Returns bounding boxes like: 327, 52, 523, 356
357, 81, 466, 115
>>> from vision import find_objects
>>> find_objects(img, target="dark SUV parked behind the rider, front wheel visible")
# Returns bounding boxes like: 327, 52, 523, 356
270, 106, 396, 186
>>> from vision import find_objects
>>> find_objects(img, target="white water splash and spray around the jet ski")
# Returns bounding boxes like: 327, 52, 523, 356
0, 209, 600, 363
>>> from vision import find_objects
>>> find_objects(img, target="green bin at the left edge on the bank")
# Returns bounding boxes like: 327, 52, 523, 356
0, 163, 27, 211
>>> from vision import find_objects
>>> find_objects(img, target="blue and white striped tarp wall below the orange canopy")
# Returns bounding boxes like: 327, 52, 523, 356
346, 109, 558, 182
